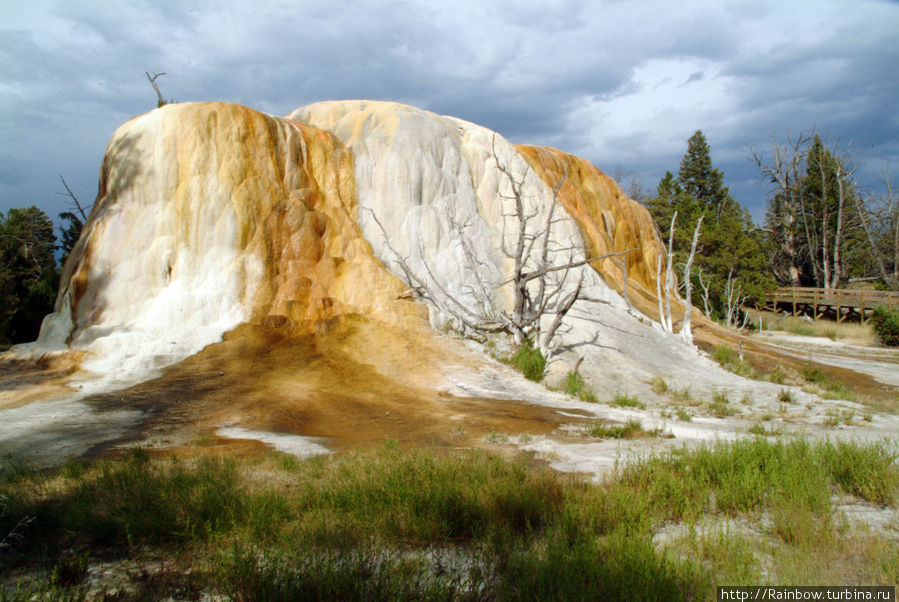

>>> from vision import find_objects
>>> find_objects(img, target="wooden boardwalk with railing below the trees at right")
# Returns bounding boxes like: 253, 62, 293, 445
765, 287, 899, 322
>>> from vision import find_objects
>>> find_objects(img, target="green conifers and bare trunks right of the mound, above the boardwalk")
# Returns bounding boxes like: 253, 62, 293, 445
640, 130, 899, 326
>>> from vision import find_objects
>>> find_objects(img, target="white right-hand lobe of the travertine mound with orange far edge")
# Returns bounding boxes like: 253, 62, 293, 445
290, 101, 662, 326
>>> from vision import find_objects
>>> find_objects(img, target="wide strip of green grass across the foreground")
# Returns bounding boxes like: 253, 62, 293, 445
0, 436, 899, 600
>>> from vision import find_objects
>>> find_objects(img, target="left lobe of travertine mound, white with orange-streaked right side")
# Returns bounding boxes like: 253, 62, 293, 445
38, 103, 421, 384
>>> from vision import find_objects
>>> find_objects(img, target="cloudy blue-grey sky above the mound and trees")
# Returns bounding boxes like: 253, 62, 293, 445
0, 0, 899, 225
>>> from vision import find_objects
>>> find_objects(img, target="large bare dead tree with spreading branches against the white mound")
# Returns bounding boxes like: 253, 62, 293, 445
369, 135, 634, 366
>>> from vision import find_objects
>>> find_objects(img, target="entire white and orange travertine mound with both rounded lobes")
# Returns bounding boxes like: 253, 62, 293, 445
31, 101, 661, 379
